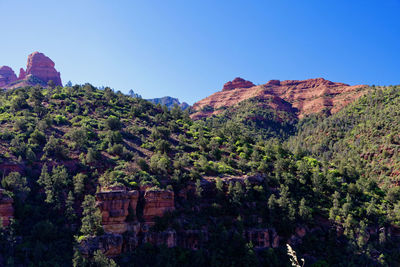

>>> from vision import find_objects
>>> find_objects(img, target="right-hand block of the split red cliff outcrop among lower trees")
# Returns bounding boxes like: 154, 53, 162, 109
143, 190, 175, 225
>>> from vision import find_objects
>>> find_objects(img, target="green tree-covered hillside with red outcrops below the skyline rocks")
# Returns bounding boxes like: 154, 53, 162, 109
0, 84, 400, 266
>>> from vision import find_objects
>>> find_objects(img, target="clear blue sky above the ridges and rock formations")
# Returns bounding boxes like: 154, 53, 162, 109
0, 0, 400, 104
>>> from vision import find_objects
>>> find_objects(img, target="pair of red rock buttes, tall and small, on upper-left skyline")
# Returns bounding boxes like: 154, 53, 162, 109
0, 52, 62, 89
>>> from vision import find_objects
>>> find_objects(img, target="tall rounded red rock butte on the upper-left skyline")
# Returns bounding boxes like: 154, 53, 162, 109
26, 52, 62, 86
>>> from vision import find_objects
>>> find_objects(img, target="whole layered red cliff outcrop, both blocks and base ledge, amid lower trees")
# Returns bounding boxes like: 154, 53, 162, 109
80, 188, 177, 257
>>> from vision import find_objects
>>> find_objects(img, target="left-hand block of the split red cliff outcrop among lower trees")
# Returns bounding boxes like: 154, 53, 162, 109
96, 189, 139, 233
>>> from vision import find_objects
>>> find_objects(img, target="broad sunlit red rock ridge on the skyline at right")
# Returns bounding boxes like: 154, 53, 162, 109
192, 78, 367, 119
